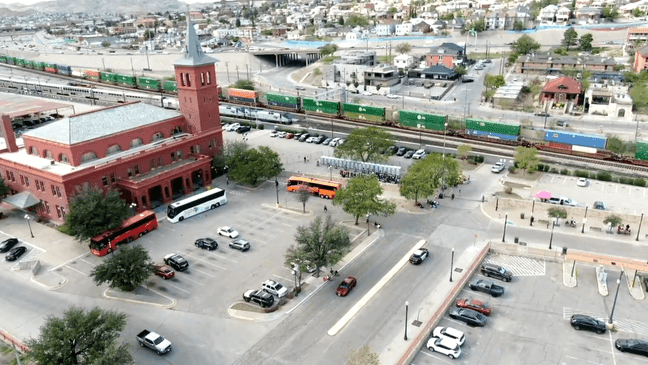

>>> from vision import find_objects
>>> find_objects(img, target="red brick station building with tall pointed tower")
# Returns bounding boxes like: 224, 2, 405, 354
0, 19, 223, 222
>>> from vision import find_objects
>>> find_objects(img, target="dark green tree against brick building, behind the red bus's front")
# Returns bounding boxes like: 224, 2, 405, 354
65, 183, 128, 242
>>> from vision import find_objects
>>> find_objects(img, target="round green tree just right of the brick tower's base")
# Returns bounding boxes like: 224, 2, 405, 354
227, 146, 283, 185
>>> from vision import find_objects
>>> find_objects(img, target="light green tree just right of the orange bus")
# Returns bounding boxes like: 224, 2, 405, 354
333, 174, 396, 224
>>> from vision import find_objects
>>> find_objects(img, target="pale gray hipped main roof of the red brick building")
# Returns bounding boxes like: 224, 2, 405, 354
23, 103, 180, 145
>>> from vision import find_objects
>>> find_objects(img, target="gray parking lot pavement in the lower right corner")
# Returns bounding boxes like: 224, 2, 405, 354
412, 254, 648, 365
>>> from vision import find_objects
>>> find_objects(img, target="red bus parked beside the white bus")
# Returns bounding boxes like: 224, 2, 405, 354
90, 210, 157, 256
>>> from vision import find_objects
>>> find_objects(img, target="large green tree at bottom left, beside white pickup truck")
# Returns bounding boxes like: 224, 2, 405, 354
25, 307, 133, 365
